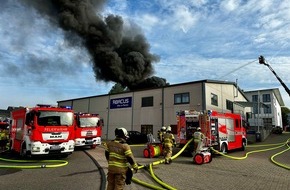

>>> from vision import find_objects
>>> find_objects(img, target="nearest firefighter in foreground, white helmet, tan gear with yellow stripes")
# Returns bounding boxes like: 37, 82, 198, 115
105, 128, 138, 190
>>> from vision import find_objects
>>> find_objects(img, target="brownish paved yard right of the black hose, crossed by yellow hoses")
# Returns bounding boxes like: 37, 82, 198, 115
86, 132, 290, 190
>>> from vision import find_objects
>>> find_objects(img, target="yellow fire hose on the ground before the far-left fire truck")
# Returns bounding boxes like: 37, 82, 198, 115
0, 151, 68, 169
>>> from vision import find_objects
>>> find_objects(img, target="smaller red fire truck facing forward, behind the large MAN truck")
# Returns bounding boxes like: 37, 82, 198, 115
75, 113, 103, 148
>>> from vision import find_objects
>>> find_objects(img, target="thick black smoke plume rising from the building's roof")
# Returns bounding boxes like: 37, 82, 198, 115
24, 0, 168, 90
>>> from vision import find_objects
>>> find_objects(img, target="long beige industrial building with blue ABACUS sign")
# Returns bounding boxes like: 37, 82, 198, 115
57, 80, 260, 139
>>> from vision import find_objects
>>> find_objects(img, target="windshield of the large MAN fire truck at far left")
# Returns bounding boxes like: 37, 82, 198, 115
37, 111, 74, 126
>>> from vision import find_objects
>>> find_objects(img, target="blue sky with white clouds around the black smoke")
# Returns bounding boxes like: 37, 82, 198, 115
0, 0, 290, 109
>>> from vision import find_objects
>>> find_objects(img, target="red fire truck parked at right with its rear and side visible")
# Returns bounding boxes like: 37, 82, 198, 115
177, 110, 247, 152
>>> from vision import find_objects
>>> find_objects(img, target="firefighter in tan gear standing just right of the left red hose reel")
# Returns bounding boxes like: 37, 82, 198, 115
163, 126, 176, 164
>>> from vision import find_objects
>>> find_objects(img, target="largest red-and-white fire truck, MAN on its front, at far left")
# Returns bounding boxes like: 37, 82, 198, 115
10, 104, 74, 157
